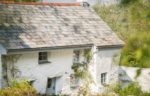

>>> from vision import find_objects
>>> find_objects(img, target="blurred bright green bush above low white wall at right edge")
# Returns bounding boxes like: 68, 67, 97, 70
121, 32, 150, 68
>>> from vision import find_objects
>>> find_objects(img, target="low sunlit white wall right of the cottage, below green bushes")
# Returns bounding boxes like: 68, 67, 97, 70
120, 66, 150, 92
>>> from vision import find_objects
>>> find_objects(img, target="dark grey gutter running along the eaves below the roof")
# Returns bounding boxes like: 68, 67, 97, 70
7, 44, 124, 54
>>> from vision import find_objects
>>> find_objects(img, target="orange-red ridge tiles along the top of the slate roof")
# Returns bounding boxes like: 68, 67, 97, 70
0, 1, 80, 6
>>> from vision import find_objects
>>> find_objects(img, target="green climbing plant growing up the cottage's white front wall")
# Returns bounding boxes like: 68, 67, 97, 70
72, 49, 93, 96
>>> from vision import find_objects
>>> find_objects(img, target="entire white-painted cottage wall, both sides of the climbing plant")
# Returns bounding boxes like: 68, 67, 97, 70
1, 46, 120, 94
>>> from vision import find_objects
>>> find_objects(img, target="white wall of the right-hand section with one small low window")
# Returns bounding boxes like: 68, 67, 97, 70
96, 48, 121, 91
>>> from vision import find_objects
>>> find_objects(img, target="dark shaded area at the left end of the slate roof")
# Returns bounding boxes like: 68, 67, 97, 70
0, 5, 30, 48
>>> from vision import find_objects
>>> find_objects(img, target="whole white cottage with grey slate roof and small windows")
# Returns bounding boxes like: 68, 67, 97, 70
0, 3, 124, 94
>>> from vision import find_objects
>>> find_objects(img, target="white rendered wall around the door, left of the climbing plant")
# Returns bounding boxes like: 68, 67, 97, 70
15, 50, 73, 93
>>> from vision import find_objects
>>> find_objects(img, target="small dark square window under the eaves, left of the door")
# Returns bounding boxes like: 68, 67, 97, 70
39, 52, 48, 64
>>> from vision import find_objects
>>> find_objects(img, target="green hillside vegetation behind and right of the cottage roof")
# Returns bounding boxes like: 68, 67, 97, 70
94, 0, 150, 68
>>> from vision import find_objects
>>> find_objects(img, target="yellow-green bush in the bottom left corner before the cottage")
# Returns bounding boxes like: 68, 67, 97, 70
0, 81, 36, 96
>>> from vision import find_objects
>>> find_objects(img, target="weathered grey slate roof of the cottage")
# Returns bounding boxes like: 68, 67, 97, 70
0, 4, 123, 49
